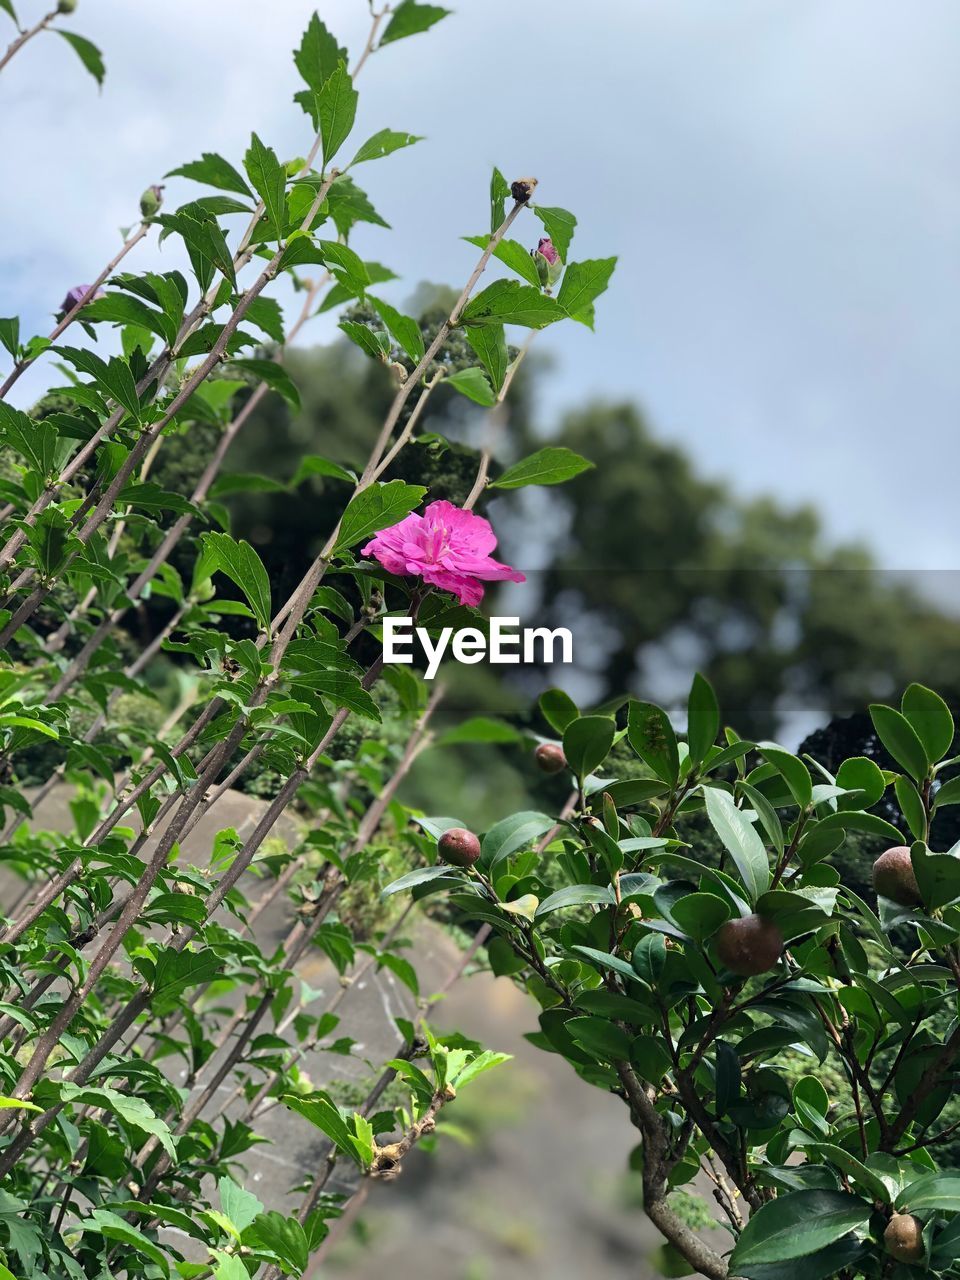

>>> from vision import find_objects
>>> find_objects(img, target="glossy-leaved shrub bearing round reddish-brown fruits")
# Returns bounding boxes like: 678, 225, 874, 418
388, 677, 960, 1280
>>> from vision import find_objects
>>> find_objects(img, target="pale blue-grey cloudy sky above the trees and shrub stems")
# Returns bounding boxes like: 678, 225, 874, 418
0, 0, 960, 568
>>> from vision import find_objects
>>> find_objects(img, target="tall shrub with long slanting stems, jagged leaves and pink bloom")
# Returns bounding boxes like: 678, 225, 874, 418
0, 0, 613, 1280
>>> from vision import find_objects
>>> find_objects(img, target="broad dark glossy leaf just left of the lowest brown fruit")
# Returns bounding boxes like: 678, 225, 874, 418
730, 1190, 873, 1275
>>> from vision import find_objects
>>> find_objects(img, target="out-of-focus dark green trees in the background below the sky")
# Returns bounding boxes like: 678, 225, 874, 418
156, 299, 960, 736
